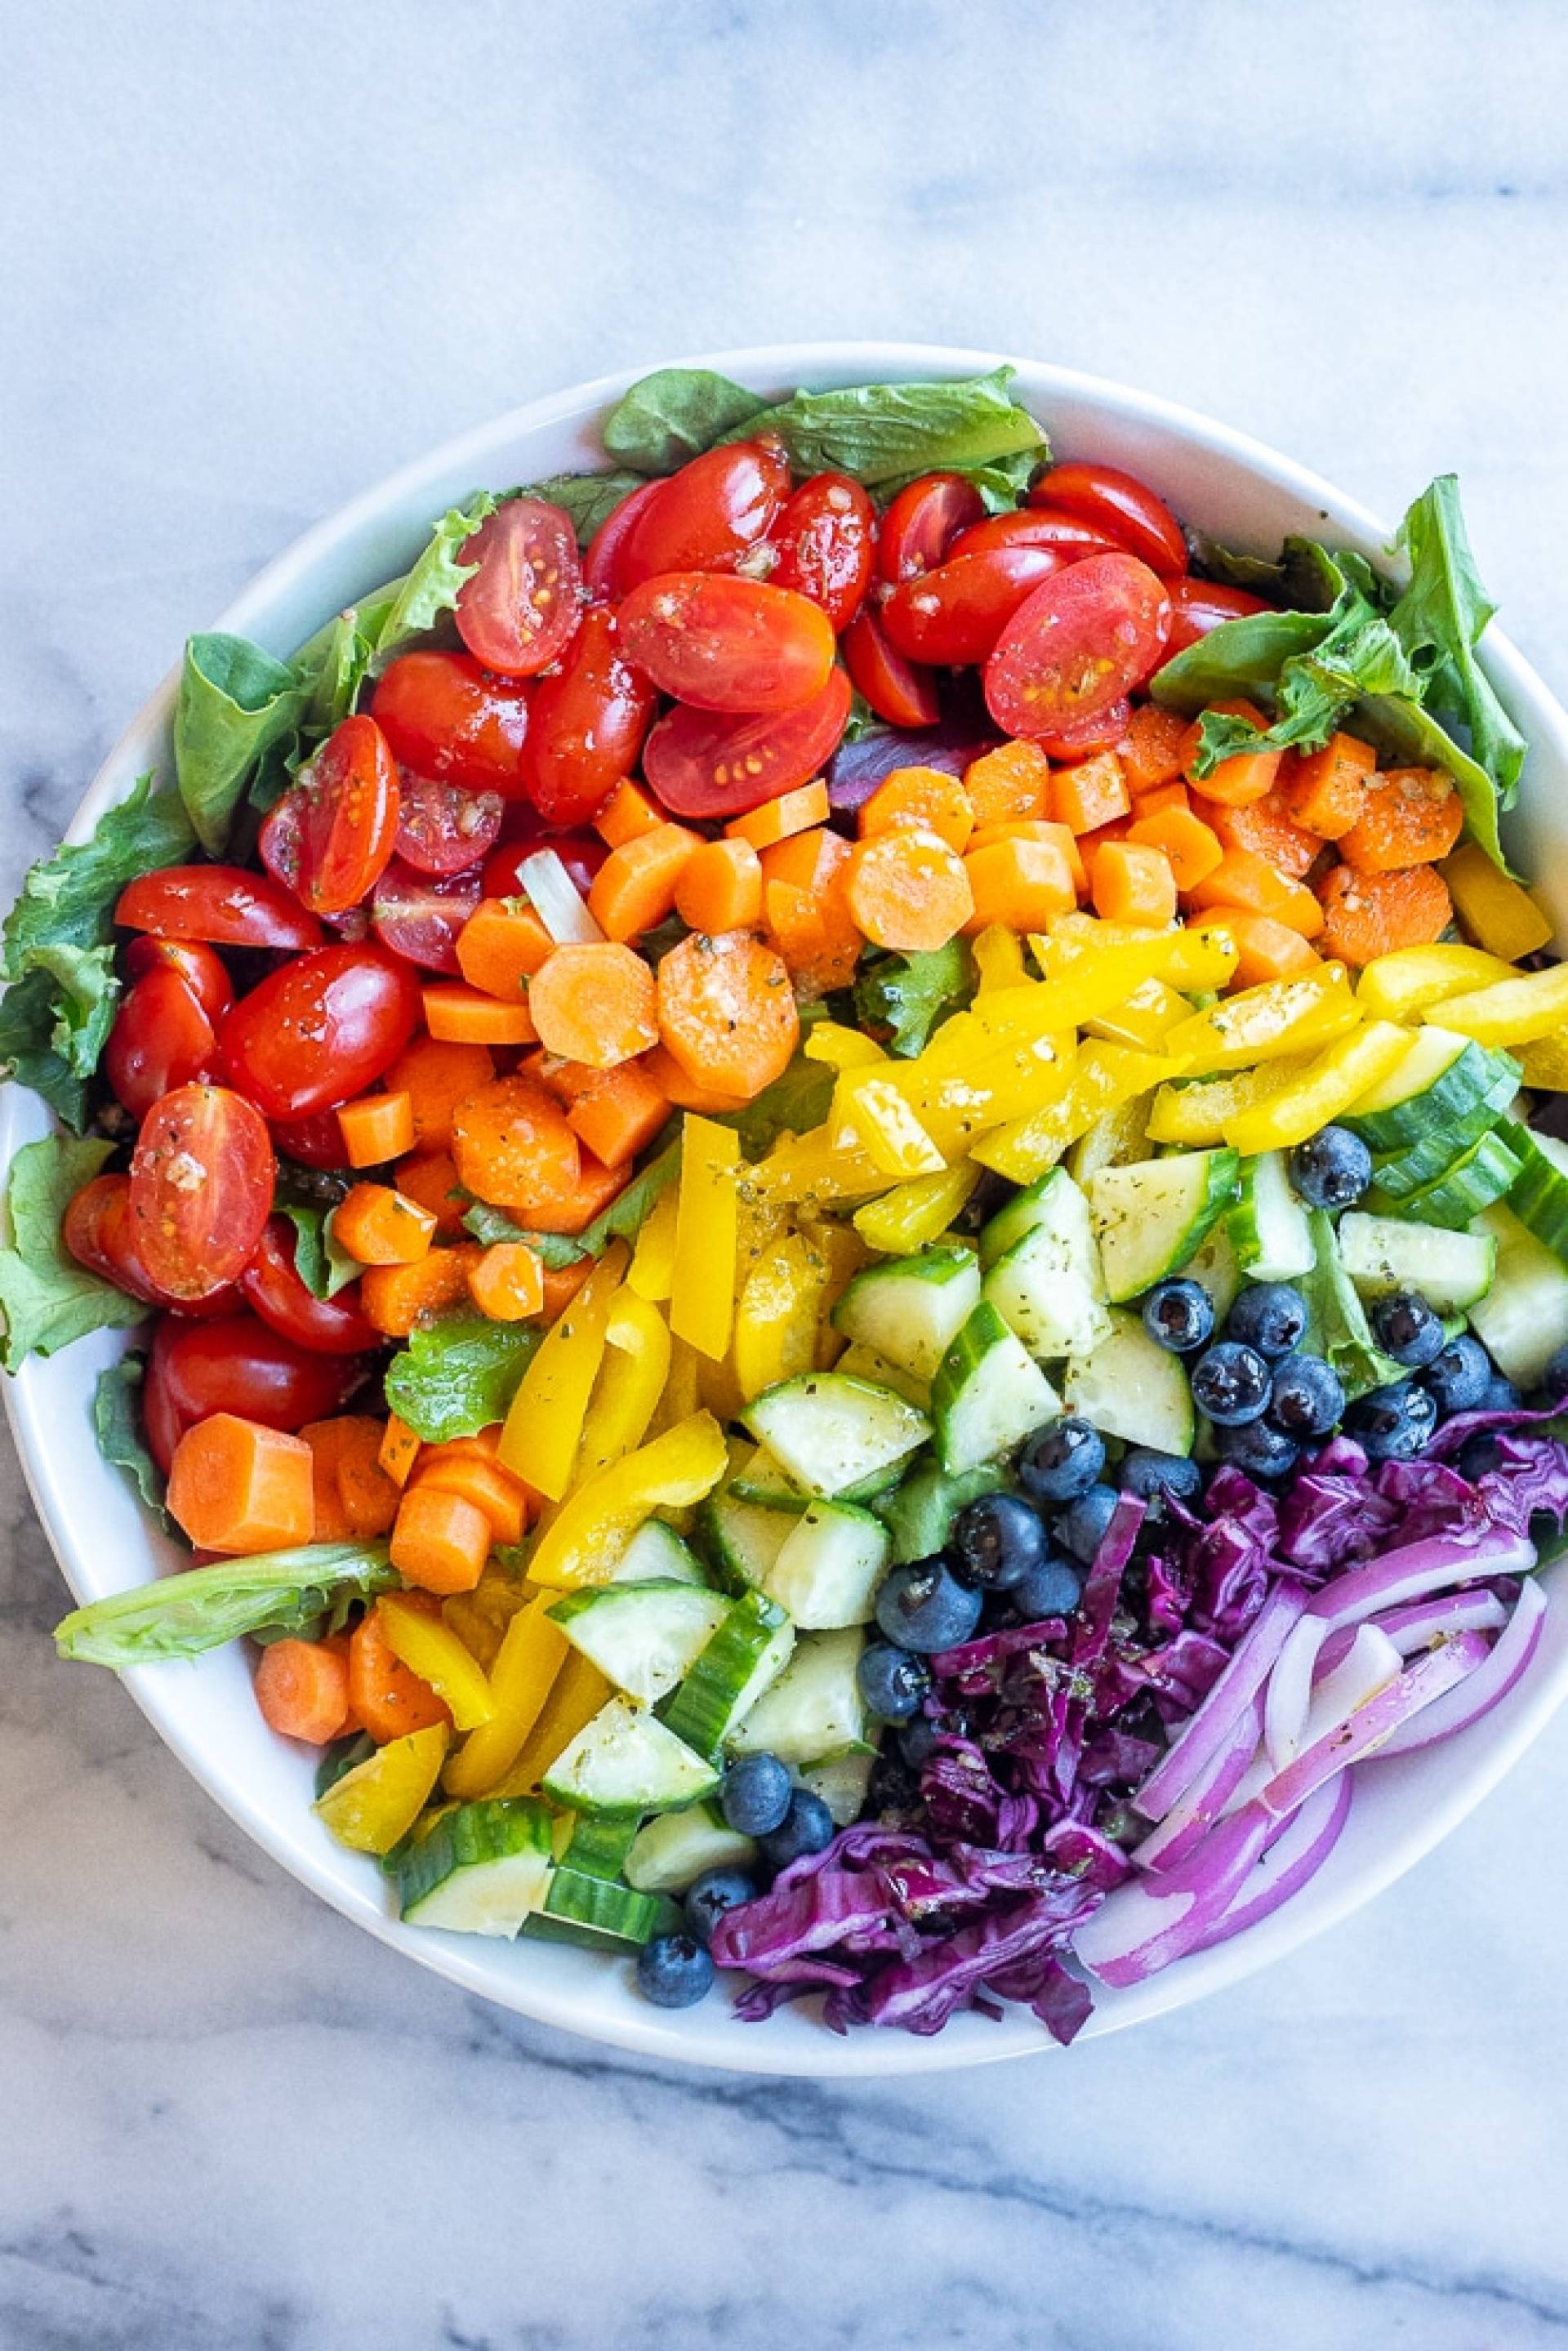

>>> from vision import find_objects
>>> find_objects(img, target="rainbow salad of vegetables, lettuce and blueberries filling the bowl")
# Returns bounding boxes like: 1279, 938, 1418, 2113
12, 352, 1568, 2041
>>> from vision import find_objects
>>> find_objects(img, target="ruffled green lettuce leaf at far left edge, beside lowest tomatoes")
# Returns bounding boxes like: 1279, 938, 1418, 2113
0, 1136, 145, 1370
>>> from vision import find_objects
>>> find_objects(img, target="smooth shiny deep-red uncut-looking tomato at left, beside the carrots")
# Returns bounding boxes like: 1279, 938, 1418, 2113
219, 947, 421, 1119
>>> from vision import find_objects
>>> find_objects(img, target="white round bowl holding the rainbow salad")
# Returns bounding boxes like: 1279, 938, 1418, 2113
12, 343, 1568, 2076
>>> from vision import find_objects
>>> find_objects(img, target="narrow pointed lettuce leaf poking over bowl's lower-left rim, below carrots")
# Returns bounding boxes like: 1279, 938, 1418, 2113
54, 1543, 397, 1674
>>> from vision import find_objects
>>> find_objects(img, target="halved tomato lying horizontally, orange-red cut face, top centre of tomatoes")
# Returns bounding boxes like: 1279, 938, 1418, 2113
621, 572, 832, 712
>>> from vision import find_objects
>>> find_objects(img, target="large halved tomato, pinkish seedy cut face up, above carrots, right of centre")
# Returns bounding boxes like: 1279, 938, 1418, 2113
985, 554, 1171, 741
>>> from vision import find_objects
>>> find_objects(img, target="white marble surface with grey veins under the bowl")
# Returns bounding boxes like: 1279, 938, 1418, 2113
0, 0, 1568, 2351
